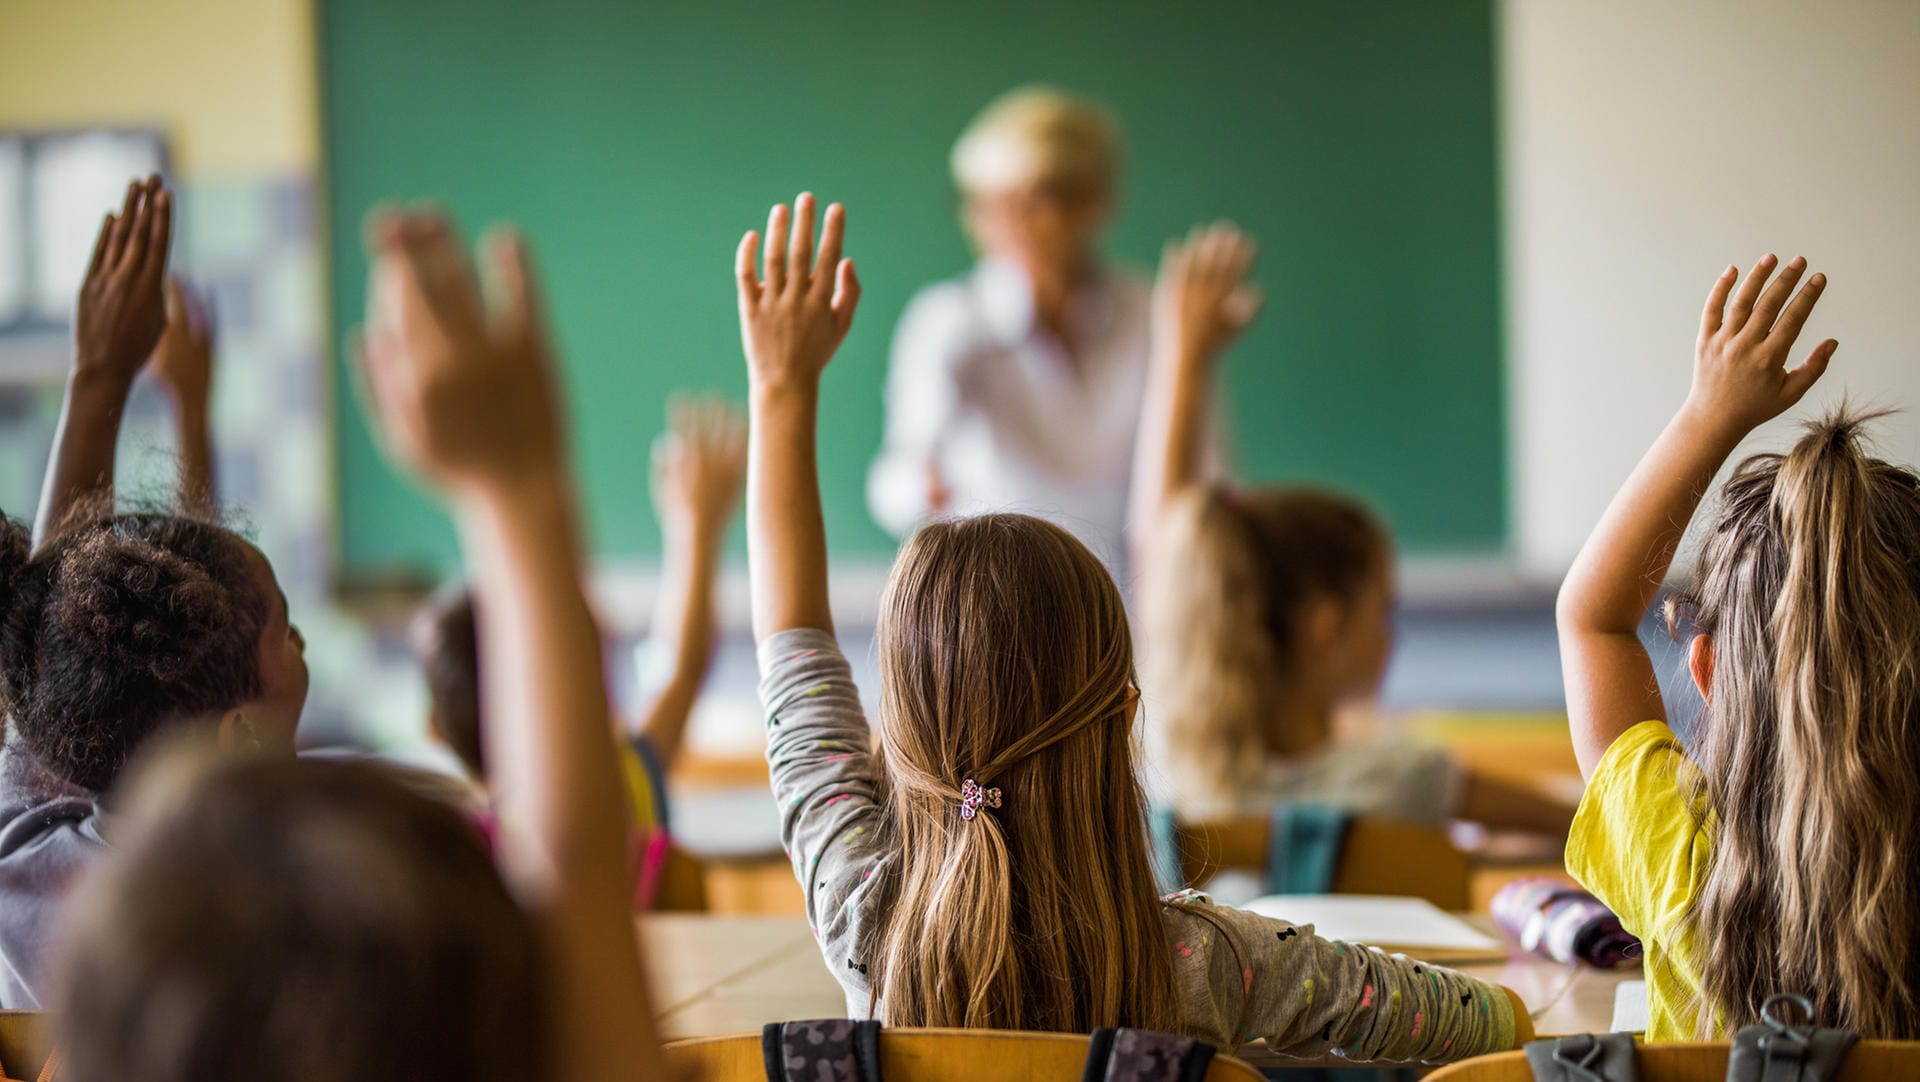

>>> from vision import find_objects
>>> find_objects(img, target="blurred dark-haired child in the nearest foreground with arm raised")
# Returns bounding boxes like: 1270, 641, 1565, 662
54, 215, 666, 1082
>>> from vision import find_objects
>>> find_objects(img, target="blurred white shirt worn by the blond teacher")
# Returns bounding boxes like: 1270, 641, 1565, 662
866, 261, 1152, 585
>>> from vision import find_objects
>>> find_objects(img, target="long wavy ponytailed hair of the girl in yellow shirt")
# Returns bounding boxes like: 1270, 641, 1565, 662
1684, 409, 1920, 1040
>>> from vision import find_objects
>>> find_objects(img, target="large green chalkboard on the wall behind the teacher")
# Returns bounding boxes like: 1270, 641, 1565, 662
321, 0, 1505, 577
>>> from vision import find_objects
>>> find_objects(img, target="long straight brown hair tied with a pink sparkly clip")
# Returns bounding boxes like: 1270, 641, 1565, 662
874, 514, 1179, 1032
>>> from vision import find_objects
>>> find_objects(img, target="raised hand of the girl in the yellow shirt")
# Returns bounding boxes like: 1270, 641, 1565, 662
1688, 255, 1839, 435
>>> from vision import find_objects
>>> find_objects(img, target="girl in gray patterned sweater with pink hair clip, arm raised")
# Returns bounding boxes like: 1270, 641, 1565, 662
737, 196, 1530, 1061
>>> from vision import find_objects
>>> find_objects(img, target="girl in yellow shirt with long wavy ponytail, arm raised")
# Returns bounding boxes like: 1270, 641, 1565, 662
1559, 255, 1920, 1040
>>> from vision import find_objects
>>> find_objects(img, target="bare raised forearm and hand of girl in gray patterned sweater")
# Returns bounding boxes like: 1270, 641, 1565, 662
733, 194, 860, 641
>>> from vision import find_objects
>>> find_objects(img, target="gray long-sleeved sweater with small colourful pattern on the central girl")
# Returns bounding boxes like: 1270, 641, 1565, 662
760, 629, 1513, 1063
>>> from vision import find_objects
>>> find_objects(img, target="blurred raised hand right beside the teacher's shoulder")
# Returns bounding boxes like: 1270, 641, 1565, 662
1154, 223, 1261, 365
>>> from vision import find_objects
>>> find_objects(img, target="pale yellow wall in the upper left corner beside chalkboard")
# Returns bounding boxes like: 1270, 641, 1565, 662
0, 0, 319, 176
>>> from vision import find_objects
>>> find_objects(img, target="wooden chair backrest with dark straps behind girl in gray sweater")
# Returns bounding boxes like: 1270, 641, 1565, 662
666, 1028, 1263, 1082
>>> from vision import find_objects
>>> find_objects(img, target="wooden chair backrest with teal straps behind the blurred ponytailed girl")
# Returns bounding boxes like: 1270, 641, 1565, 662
1175, 815, 1473, 911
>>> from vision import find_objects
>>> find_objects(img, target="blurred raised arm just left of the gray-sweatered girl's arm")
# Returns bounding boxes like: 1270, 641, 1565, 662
637, 399, 747, 767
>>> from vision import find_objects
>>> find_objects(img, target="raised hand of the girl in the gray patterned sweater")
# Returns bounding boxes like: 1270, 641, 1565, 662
733, 194, 860, 388
